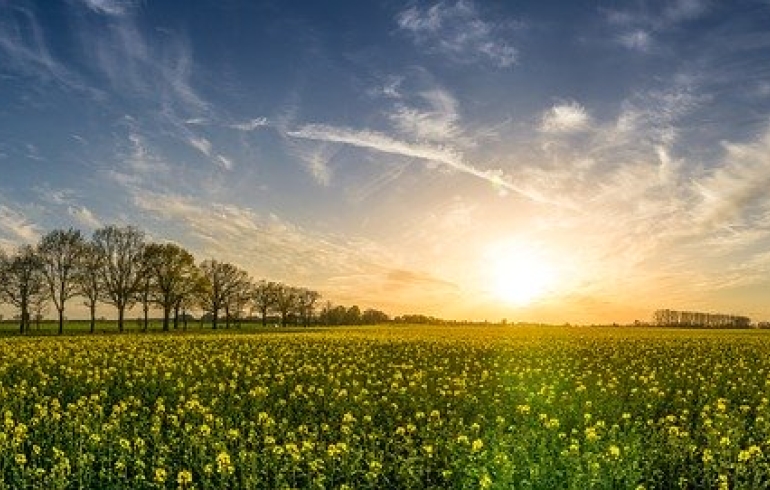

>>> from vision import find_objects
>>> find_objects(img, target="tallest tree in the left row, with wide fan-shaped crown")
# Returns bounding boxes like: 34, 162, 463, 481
93, 225, 144, 332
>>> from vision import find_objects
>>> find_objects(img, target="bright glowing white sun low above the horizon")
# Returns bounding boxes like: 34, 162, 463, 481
489, 245, 556, 306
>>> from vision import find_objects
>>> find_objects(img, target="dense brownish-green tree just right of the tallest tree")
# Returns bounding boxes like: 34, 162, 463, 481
144, 243, 196, 331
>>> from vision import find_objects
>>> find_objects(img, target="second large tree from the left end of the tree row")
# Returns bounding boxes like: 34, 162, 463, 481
37, 228, 85, 335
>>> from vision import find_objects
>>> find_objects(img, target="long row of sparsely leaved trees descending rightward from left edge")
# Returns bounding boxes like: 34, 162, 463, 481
0, 225, 390, 334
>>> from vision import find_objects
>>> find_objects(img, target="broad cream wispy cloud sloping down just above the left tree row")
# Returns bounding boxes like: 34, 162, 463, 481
130, 187, 412, 287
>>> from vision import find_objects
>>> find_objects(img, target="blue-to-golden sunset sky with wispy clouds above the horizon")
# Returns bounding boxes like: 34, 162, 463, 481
0, 0, 770, 323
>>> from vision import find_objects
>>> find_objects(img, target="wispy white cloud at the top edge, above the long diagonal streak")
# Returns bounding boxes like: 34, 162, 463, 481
396, 0, 517, 68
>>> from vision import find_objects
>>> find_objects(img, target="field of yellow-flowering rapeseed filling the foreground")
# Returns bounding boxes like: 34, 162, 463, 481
0, 326, 770, 489
